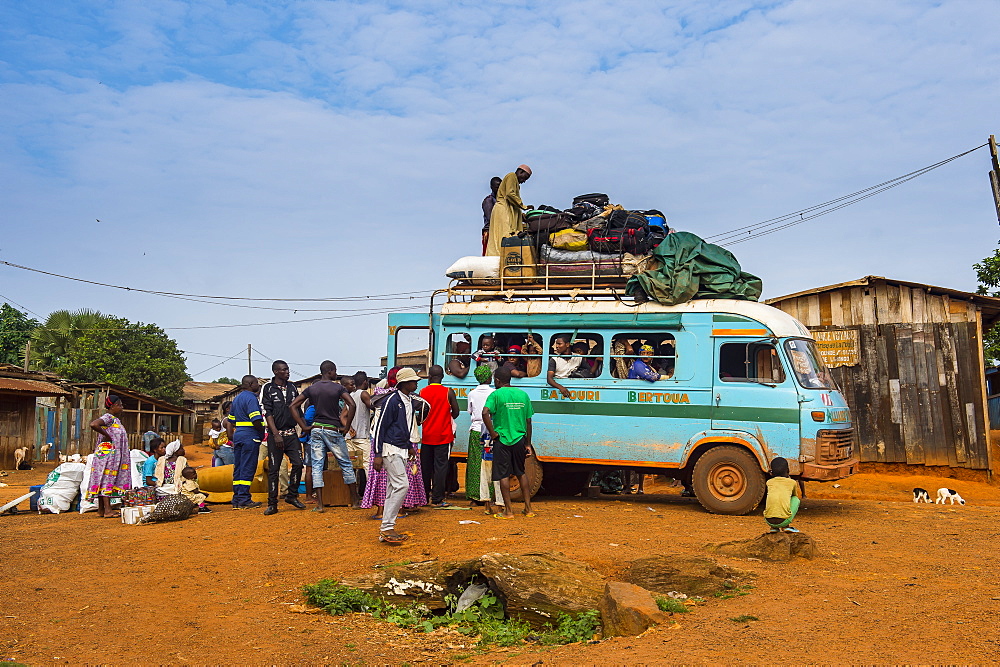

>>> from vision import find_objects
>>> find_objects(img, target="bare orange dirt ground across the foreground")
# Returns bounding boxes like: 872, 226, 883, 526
0, 450, 1000, 665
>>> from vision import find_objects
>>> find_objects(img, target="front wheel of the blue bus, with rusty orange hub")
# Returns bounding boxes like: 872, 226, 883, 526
691, 445, 765, 514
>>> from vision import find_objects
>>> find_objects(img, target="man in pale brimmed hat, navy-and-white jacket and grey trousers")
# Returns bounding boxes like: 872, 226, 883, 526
373, 368, 420, 544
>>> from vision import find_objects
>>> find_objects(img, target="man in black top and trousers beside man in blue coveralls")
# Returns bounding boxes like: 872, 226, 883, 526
260, 359, 306, 516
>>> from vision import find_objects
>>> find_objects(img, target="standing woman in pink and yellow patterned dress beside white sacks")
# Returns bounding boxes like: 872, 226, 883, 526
87, 394, 132, 518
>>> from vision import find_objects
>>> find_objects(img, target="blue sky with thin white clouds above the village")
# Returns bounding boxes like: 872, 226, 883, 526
0, 0, 1000, 380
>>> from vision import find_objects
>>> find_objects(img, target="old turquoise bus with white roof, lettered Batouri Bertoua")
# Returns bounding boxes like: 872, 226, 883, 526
387, 290, 858, 514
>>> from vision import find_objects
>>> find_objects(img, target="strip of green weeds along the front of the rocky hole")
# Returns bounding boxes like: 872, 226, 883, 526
303, 579, 596, 646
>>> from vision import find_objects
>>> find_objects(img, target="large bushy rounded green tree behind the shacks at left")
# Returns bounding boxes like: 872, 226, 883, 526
60, 317, 191, 404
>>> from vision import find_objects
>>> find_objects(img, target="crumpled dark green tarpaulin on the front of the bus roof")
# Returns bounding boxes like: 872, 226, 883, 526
625, 232, 763, 306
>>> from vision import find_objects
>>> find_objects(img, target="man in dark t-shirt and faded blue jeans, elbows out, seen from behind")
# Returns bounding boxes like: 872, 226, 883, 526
290, 359, 361, 512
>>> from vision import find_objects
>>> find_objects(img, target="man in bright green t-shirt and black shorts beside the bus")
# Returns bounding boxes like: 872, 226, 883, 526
483, 368, 535, 519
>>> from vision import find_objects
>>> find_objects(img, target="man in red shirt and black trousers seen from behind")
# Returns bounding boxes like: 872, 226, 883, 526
420, 366, 458, 507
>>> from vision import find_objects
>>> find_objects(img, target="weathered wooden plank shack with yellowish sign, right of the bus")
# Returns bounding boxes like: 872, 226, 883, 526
767, 276, 1000, 476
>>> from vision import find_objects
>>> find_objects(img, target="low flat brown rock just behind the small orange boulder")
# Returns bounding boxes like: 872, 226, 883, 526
623, 556, 747, 596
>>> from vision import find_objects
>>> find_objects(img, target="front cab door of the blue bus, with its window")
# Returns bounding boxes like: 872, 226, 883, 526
712, 338, 799, 460
